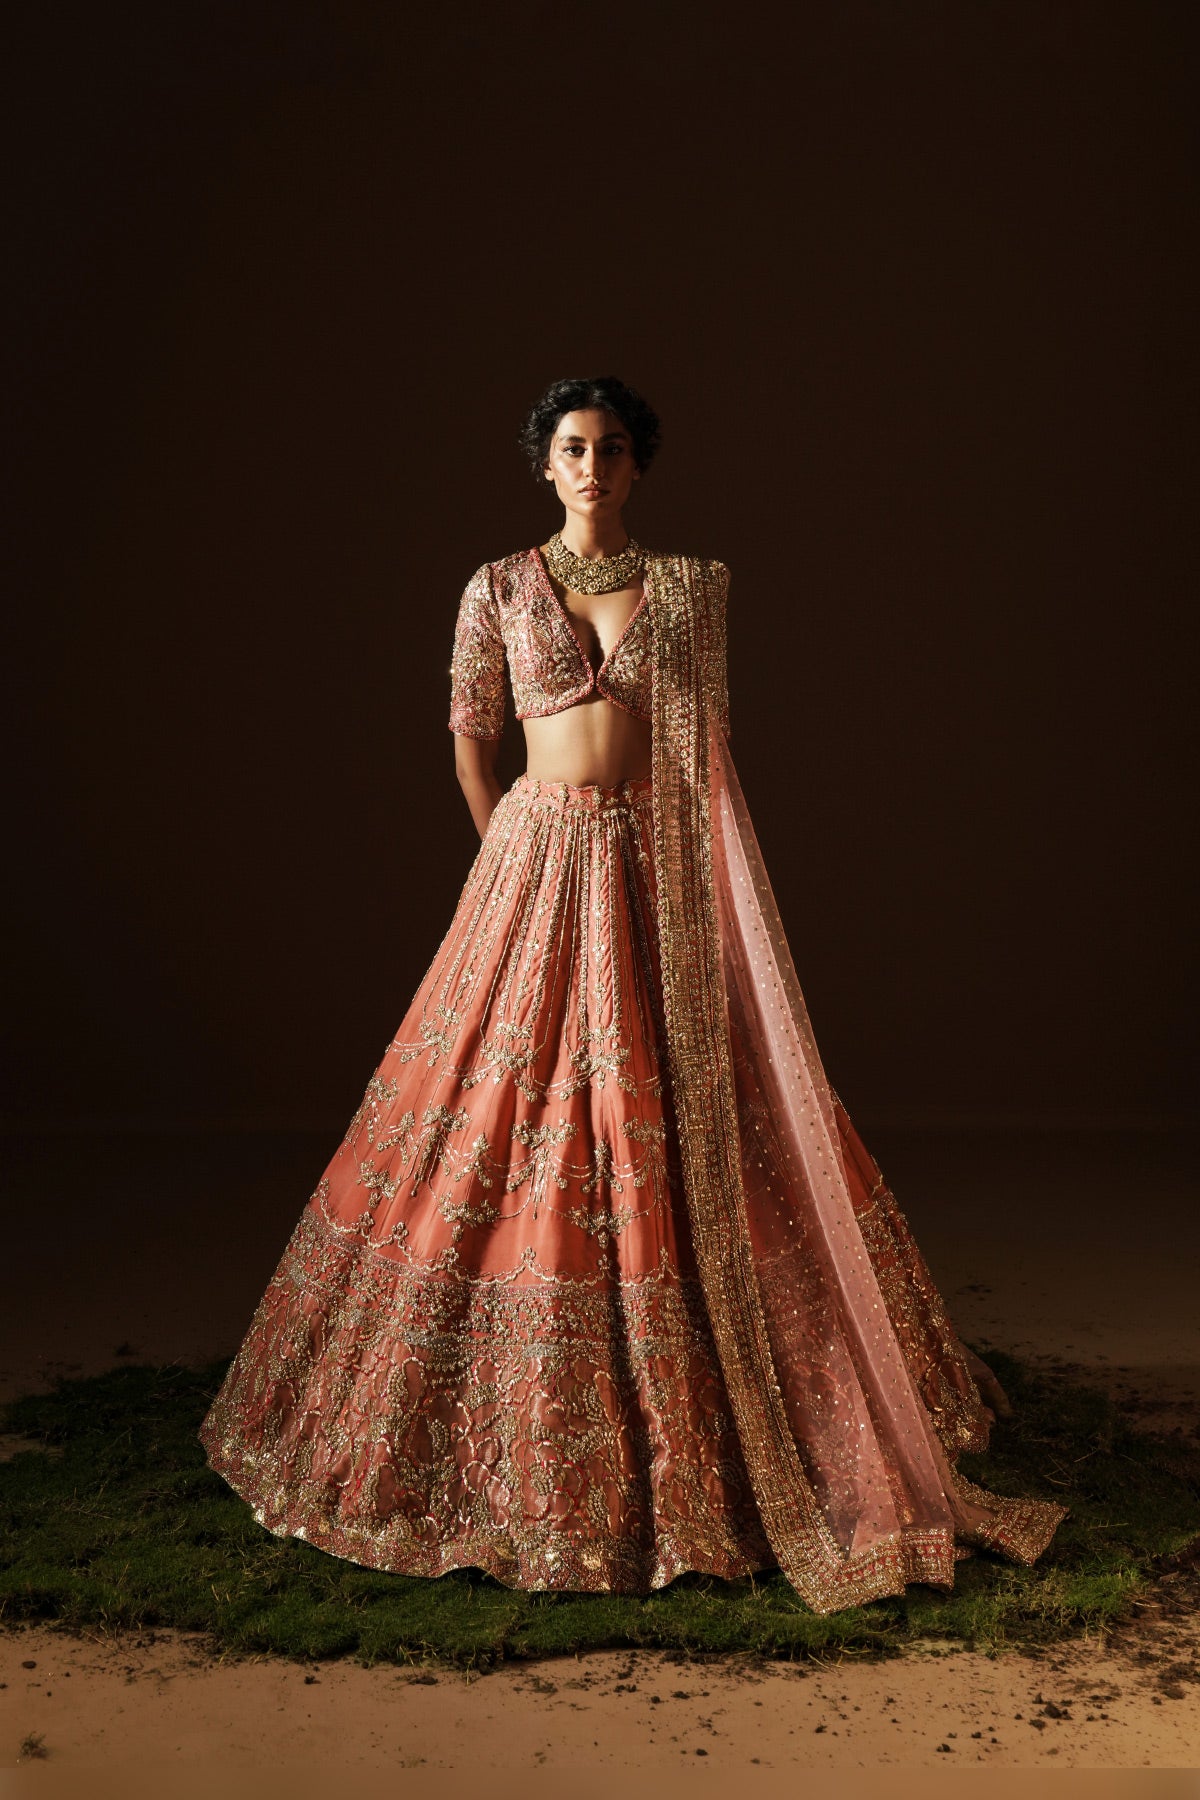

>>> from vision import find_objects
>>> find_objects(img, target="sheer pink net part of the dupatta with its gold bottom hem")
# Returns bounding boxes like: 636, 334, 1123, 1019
707, 724, 1065, 1611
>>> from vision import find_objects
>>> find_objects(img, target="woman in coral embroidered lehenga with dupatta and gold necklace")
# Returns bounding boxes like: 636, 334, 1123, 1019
201, 376, 1063, 1611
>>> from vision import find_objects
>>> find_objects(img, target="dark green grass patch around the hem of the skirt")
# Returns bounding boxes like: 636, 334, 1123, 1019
0, 1352, 1200, 1667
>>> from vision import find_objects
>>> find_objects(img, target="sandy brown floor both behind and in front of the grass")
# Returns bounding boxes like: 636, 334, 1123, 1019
0, 1132, 1200, 1771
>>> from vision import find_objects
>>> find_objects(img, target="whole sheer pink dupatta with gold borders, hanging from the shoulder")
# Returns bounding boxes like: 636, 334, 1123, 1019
651, 558, 1065, 1611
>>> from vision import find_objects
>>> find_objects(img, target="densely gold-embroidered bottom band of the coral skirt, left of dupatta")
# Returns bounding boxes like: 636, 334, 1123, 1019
201, 1210, 772, 1593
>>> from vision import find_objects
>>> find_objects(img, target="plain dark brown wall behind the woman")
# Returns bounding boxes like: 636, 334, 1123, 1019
5, 0, 1195, 1121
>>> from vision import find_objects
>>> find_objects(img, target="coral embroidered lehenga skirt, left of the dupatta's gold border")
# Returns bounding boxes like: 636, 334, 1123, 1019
201, 776, 775, 1593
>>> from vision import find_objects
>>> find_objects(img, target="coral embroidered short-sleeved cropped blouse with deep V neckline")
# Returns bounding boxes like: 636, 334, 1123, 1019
450, 547, 729, 738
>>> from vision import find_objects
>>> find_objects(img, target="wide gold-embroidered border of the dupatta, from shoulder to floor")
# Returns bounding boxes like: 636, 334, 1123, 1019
648, 543, 1061, 1613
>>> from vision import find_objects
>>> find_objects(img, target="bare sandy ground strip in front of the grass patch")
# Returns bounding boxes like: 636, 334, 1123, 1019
0, 1593, 1200, 1791
